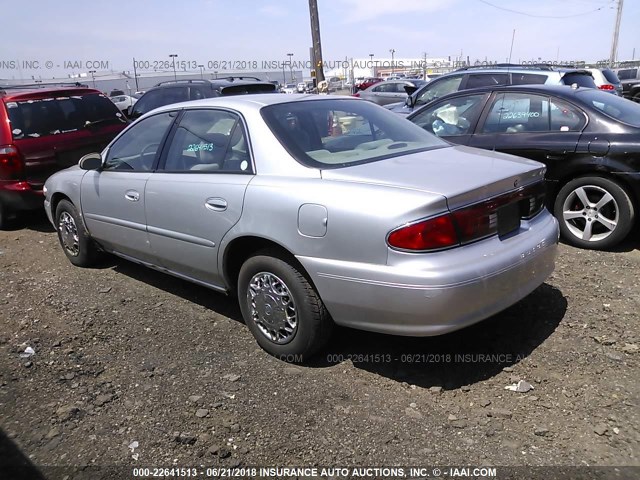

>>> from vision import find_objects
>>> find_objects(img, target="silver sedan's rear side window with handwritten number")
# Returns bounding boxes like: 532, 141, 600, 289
163, 110, 252, 173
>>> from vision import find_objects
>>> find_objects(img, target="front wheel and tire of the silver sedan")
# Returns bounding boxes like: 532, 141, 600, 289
56, 200, 100, 267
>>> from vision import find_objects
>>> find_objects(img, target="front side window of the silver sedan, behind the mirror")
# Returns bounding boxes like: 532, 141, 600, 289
102, 112, 176, 172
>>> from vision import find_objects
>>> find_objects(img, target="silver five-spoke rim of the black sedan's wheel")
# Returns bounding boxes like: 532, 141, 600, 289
562, 185, 620, 242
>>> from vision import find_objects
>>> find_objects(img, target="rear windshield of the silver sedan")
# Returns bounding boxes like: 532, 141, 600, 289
261, 99, 448, 168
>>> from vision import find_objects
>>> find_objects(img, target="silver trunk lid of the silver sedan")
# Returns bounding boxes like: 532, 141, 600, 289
322, 146, 545, 209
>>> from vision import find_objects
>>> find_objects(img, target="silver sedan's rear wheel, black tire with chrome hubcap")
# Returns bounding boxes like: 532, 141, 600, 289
238, 251, 333, 363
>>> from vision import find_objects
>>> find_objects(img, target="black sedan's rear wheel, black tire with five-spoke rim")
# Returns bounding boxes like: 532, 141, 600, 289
553, 176, 635, 250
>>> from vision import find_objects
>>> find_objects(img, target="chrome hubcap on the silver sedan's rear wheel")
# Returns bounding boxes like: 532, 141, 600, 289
247, 272, 298, 344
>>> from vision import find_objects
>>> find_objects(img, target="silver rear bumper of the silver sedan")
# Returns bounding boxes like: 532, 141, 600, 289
298, 210, 558, 336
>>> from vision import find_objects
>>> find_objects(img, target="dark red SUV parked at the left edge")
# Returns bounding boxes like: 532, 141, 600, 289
0, 85, 127, 228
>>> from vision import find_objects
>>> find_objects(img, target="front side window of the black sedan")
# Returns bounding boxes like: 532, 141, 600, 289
411, 95, 485, 137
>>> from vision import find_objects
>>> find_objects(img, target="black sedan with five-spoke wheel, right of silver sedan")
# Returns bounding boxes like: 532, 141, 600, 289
407, 85, 640, 249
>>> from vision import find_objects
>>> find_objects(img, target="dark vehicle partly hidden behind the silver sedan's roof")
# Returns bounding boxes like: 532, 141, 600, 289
129, 77, 277, 119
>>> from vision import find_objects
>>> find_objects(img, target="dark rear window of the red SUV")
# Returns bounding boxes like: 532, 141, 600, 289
6, 93, 126, 140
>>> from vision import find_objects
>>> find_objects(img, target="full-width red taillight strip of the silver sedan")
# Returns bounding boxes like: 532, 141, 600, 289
387, 182, 545, 252
